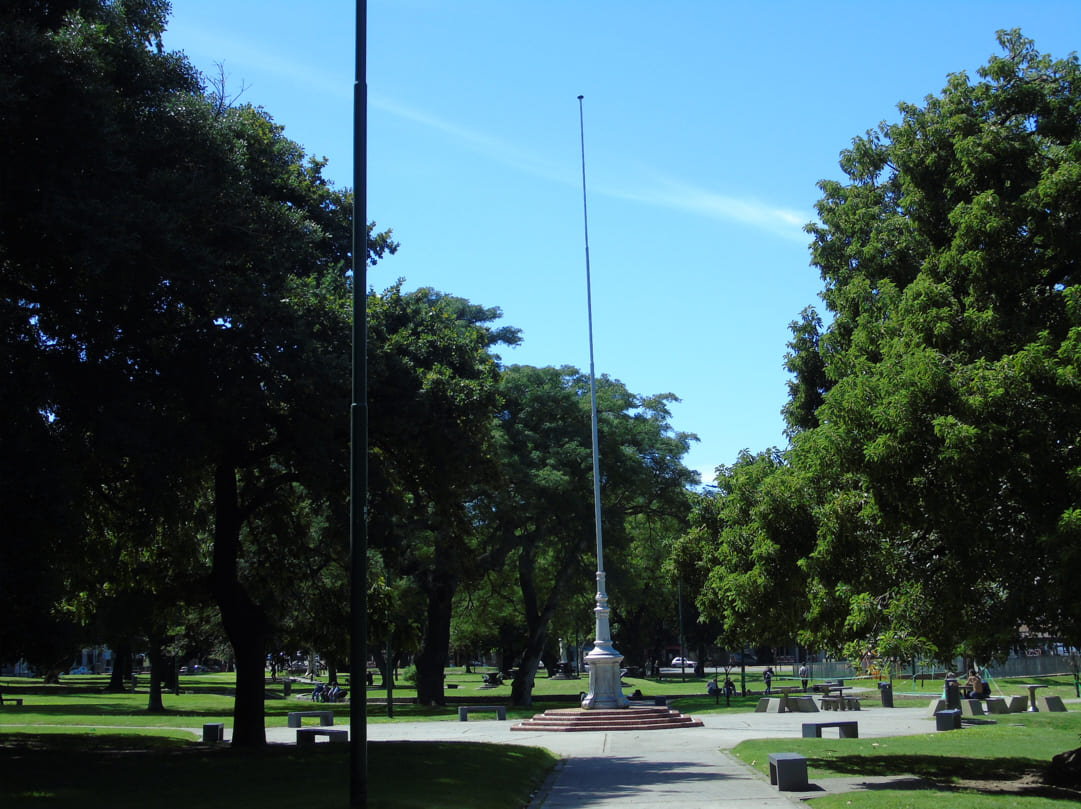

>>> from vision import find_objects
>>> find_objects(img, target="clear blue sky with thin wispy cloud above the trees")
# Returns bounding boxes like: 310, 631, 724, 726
165, 0, 1081, 482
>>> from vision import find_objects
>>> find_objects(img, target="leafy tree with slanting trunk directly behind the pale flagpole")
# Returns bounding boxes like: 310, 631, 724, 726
478, 366, 696, 705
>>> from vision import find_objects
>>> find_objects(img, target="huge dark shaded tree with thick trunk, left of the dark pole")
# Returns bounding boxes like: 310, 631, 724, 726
0, 0, 393, 745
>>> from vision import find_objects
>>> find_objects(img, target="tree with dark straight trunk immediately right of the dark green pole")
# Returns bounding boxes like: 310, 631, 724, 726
369, 282, 519, 704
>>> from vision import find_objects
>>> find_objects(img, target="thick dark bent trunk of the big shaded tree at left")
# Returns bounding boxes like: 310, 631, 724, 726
211, 464, 268, 747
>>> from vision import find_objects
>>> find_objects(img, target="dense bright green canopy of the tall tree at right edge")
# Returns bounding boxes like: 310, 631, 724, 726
786, 31, 1081, 659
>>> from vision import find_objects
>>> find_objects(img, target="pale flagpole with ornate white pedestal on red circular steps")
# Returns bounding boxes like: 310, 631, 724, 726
578, 95, 630, 708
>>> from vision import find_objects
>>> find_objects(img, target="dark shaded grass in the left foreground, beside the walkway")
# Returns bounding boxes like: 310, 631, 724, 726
0, 733, 557, 809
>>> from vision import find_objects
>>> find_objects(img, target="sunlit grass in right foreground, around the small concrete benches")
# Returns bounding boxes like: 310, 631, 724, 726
733, 712, 1081, 809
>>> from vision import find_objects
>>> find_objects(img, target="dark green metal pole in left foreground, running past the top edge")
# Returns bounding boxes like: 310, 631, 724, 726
349, 0, 368, 809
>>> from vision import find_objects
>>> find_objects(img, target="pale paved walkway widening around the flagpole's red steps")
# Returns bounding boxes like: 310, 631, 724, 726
267, 707, 935, 809
